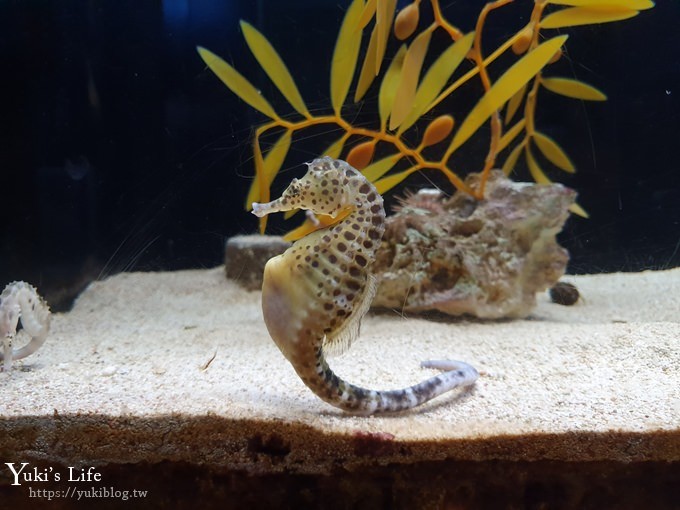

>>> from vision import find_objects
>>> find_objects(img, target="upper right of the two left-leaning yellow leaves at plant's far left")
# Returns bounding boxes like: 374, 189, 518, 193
241, 21, 309, 118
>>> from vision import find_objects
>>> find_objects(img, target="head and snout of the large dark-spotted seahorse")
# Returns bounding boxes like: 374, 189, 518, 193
253, 156, 357, 218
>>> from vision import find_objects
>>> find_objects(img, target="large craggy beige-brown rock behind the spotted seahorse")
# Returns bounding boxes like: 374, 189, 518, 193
373, 170, 576, 319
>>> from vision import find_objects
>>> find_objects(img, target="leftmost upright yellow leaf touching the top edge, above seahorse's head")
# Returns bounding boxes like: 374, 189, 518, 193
331, 0, 364, 116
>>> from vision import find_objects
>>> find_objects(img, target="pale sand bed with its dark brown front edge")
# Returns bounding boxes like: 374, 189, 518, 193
0, 267, 680, 472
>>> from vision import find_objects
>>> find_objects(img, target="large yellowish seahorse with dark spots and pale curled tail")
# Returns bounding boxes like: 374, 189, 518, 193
253, 156, 478, 414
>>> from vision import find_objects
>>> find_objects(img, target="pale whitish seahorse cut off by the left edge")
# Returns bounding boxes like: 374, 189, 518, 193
0, 282, 51, 372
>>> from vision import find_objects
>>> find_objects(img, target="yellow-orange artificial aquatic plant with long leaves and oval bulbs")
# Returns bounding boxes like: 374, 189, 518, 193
198, 0, 654, 239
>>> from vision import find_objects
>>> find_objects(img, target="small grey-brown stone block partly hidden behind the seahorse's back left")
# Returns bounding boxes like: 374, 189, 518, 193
224, 234, 291, 290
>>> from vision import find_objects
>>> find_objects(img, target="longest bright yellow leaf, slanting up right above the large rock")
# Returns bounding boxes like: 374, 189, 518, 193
447, 35, 568, 154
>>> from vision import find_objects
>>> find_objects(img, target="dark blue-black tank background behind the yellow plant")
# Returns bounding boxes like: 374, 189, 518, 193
0, 0, 680, 308
